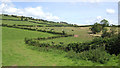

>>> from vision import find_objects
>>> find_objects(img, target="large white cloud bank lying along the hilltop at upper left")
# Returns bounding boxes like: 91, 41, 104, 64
0, 3, 59, 21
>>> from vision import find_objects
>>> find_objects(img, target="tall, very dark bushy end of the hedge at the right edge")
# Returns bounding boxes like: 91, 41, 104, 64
91, 34, 120, 55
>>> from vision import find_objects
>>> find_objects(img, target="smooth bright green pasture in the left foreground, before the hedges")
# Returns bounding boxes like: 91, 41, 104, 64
2, 27, 99, 66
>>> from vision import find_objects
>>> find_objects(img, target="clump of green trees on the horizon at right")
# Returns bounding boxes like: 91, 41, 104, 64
90, 19, 117, 38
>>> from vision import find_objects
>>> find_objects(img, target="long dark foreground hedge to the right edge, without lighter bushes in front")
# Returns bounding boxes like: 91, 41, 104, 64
25, 34, 120, 55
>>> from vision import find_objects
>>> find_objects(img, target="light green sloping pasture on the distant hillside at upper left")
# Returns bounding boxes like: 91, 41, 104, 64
0, 15, 70, 26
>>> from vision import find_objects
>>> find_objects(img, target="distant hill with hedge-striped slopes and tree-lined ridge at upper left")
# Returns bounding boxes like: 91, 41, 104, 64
0, 14, 78, 27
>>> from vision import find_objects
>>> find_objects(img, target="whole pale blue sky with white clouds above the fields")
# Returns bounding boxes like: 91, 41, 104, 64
0, 0, 118, 25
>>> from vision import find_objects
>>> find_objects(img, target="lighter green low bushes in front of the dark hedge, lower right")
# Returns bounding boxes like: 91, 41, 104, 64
66, 47, 111, 64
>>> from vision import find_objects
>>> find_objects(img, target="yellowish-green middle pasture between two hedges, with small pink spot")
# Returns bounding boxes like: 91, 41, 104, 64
33, 27, 93, 44
